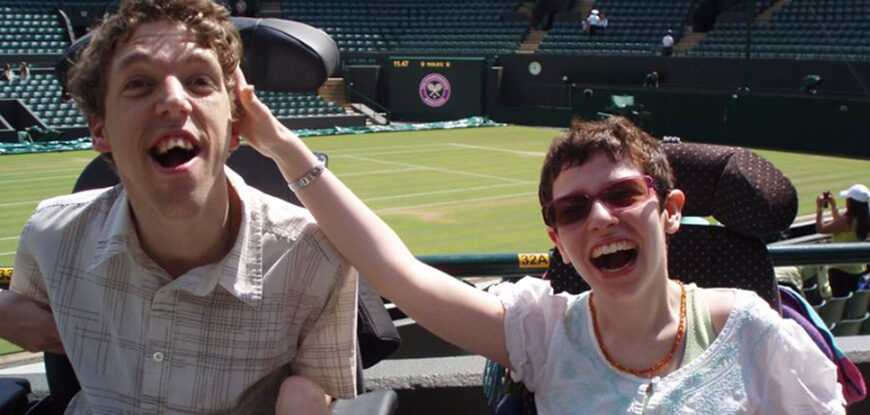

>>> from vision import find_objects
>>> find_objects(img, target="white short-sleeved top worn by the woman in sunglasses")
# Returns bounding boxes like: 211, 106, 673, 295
493, 278, 845, 415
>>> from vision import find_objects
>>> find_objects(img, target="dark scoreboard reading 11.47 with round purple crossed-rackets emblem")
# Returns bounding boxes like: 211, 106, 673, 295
387, 56, 485, 121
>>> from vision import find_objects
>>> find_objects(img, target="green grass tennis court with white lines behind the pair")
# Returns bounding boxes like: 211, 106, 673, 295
0, 127, 870, 266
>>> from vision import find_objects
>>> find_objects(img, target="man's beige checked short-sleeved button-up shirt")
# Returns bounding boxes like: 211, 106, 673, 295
10, 169, 357, 414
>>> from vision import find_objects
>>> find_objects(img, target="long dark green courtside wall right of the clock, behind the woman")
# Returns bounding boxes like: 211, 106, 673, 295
572, 86, 870, 157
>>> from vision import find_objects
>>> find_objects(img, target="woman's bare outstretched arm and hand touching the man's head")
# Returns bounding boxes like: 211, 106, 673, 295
235, 71, 510, 367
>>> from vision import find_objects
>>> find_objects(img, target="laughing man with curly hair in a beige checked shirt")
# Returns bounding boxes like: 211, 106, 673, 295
0, 0, 357, 414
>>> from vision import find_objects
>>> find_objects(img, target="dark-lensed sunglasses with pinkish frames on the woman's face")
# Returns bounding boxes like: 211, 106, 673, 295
541, 175, 655, 228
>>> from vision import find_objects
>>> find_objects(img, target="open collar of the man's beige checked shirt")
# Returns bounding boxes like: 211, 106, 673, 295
88, 166, 263, 307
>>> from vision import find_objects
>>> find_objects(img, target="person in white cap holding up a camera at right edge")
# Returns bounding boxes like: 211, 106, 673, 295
816, 184, 870, 297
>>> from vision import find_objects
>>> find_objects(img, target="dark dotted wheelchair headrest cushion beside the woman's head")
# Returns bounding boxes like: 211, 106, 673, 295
664, 143, 797, 237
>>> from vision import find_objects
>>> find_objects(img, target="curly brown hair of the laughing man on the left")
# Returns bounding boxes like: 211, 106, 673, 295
67, 0, 242, 119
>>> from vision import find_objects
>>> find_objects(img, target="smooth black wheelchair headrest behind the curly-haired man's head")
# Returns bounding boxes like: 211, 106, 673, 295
55, 17, 339, 92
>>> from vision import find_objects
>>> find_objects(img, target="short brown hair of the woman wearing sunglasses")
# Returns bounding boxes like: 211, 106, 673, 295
538, 116, 674, 214
